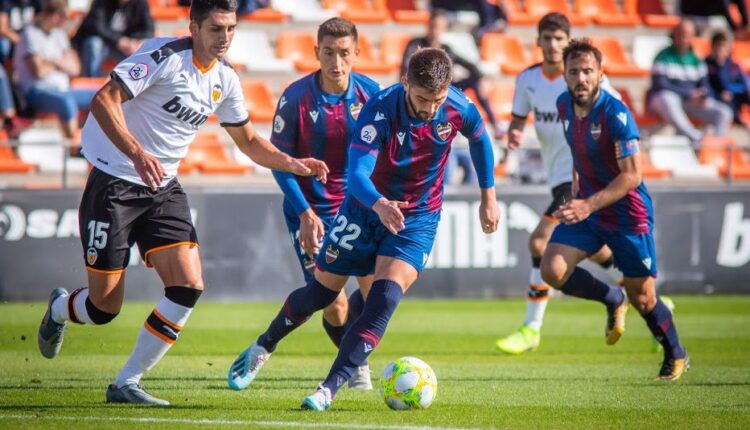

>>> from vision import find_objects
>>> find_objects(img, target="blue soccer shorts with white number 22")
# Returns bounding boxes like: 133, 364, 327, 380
316, 197, 440, 276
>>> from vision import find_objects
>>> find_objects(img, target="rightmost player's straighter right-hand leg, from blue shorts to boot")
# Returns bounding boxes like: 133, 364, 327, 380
611, 234, 689, 380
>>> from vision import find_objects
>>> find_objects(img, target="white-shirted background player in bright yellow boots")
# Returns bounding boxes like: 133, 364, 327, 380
495, 12, 617, 355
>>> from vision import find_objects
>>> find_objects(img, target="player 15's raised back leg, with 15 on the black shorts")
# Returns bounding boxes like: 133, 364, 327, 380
37, 169, 137, 358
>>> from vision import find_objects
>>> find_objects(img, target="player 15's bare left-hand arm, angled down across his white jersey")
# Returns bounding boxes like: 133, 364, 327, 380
90, 79, 165, 190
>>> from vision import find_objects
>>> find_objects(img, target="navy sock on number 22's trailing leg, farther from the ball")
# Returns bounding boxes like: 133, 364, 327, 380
258, 279, 339, 352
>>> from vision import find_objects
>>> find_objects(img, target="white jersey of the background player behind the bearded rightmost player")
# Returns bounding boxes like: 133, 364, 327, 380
512, 64, 620, 188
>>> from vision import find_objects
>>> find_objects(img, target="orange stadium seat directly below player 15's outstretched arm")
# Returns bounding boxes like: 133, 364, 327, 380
179, 133, 251, 175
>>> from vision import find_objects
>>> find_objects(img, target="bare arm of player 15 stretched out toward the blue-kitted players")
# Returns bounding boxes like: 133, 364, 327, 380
226, 122, 328, 183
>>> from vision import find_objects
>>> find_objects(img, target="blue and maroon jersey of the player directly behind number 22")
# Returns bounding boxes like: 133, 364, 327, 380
271, 71, 381, 216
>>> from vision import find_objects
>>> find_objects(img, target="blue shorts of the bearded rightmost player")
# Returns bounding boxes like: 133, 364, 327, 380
549, 220, 657, 278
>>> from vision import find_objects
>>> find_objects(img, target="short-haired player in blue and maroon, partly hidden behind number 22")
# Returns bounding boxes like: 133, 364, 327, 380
264, 18, 380, 390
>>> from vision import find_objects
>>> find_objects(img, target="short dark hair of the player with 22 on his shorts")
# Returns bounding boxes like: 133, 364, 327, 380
406, 48, 453, 92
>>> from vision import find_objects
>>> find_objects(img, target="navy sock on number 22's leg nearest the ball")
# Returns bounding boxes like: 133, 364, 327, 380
323, 279, 404, 396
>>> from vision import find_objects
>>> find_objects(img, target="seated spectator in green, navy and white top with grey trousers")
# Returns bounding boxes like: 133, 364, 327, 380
648, 20, 732, 145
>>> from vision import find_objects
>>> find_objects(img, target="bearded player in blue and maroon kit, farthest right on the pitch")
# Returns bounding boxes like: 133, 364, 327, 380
541, 39, 689, 380
